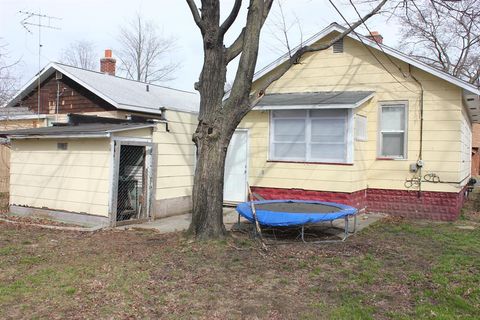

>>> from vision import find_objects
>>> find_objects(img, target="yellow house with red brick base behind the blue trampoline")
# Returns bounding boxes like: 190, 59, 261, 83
225, 24, 480, 220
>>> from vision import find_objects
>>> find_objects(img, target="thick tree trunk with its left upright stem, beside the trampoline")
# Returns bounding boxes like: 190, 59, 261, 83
189, 0, 230, 239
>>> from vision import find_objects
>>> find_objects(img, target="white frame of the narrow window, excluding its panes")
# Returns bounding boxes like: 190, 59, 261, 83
377, 101, 409, 160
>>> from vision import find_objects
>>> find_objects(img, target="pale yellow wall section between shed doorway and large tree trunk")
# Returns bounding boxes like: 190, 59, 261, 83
152, 110, 198, 200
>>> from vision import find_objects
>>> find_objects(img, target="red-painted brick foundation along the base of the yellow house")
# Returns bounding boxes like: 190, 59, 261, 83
252, 187, 465, 221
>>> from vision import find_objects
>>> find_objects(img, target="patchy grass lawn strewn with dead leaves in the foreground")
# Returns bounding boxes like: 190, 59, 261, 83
0, 212, 480, 319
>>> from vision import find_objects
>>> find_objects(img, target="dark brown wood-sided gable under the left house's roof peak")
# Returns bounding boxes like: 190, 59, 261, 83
14, 74, 115, 114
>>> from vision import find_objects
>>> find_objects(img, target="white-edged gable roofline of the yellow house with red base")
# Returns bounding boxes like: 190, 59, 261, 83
253, 23, 480, 95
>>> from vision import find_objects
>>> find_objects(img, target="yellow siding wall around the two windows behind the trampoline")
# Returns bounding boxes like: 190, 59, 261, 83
239, 39, 470, 192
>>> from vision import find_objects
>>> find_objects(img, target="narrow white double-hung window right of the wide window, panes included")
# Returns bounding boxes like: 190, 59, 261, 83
379, 103, 408, 159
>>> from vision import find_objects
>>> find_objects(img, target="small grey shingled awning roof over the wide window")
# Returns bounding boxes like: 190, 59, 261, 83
256, 91, 375, 110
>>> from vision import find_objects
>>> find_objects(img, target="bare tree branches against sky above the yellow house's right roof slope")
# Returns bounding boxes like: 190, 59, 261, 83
392, 0, 480, 85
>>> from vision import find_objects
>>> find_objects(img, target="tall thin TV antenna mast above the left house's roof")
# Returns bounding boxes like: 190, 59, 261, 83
18, 10, 62, 118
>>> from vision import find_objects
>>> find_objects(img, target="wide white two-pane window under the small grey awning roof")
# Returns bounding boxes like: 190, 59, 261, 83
270, 109, 351, 163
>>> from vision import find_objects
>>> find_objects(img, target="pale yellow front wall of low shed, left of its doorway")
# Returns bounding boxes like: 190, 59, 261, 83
10, 139, 111, 216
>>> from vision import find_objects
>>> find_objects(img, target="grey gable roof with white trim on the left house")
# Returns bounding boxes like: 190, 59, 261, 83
6, 62, 199, 114
